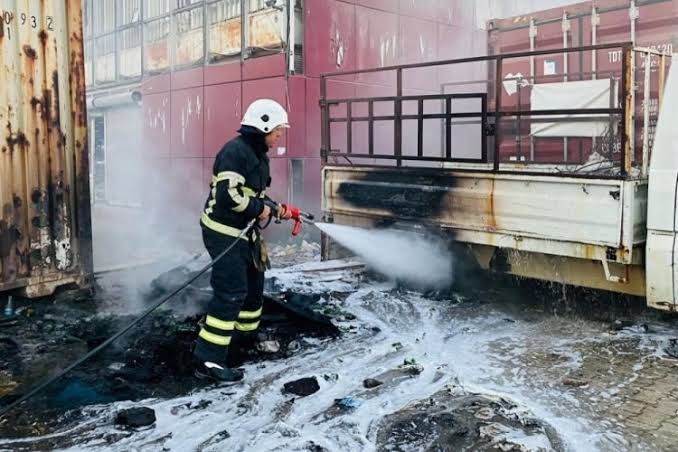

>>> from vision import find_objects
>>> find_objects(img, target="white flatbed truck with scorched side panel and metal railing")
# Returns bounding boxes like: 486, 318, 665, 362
320, 35, 678, 312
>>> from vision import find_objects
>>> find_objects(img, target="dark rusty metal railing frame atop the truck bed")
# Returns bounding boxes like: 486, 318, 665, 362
320, 42, 668, 177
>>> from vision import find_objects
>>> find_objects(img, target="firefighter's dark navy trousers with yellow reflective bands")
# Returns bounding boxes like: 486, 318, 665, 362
194, 228, 264, 367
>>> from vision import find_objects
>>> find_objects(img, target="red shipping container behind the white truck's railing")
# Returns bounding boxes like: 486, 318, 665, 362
488, 0, 678, 163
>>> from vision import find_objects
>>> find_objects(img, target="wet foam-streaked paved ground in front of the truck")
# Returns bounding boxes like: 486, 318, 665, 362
0, 245, 678, 451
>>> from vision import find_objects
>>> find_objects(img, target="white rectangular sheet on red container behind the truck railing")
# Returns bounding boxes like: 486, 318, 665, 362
530, 79, 617, 137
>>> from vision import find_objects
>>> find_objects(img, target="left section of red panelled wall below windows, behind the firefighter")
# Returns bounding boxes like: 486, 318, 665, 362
142, 55, 290, 221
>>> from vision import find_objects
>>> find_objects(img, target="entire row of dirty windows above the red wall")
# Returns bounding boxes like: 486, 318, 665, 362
82, 0, 299, 81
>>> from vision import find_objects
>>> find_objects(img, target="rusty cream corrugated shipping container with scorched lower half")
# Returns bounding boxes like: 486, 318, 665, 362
0, 0, 92, 297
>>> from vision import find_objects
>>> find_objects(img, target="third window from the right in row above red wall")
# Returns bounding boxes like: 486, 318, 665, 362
174, 5, 204, 66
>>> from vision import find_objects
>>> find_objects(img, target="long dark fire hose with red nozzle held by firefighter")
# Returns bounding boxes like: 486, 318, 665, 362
0, 207, 314, 418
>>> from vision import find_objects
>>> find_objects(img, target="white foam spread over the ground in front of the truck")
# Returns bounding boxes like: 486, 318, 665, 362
5, 266, 676, 452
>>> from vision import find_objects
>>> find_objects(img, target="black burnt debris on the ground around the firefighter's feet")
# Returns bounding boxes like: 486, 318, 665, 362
0, 270, 339, 447
